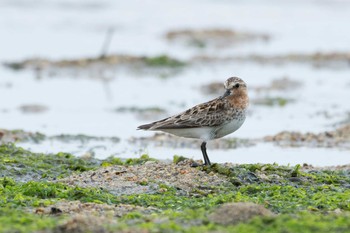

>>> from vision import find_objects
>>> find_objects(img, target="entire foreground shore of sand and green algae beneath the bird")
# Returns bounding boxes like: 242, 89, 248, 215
0, 144, 350, 232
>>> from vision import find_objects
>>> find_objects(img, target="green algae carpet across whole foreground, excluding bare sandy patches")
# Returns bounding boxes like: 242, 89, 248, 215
0, 144, 350, 233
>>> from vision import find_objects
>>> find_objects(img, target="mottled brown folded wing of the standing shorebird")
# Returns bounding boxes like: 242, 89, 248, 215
149, 99, 227, 130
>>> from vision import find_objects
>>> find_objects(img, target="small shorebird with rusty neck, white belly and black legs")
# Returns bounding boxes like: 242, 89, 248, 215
138, 77, 249, 165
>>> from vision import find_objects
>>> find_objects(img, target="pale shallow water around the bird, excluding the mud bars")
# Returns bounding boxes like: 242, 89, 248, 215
0, 0, 350, 165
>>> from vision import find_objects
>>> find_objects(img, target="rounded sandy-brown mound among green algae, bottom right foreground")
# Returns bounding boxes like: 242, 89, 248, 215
209, 202, 273, 225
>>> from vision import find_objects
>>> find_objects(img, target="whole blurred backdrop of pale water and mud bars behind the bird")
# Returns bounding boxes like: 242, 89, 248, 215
0, 0, 350, 166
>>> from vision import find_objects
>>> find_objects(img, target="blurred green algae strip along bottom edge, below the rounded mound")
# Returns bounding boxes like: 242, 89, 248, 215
114, 211, 350, 233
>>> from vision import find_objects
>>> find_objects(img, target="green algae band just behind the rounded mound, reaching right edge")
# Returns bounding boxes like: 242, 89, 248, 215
112, 181, 350, 213
